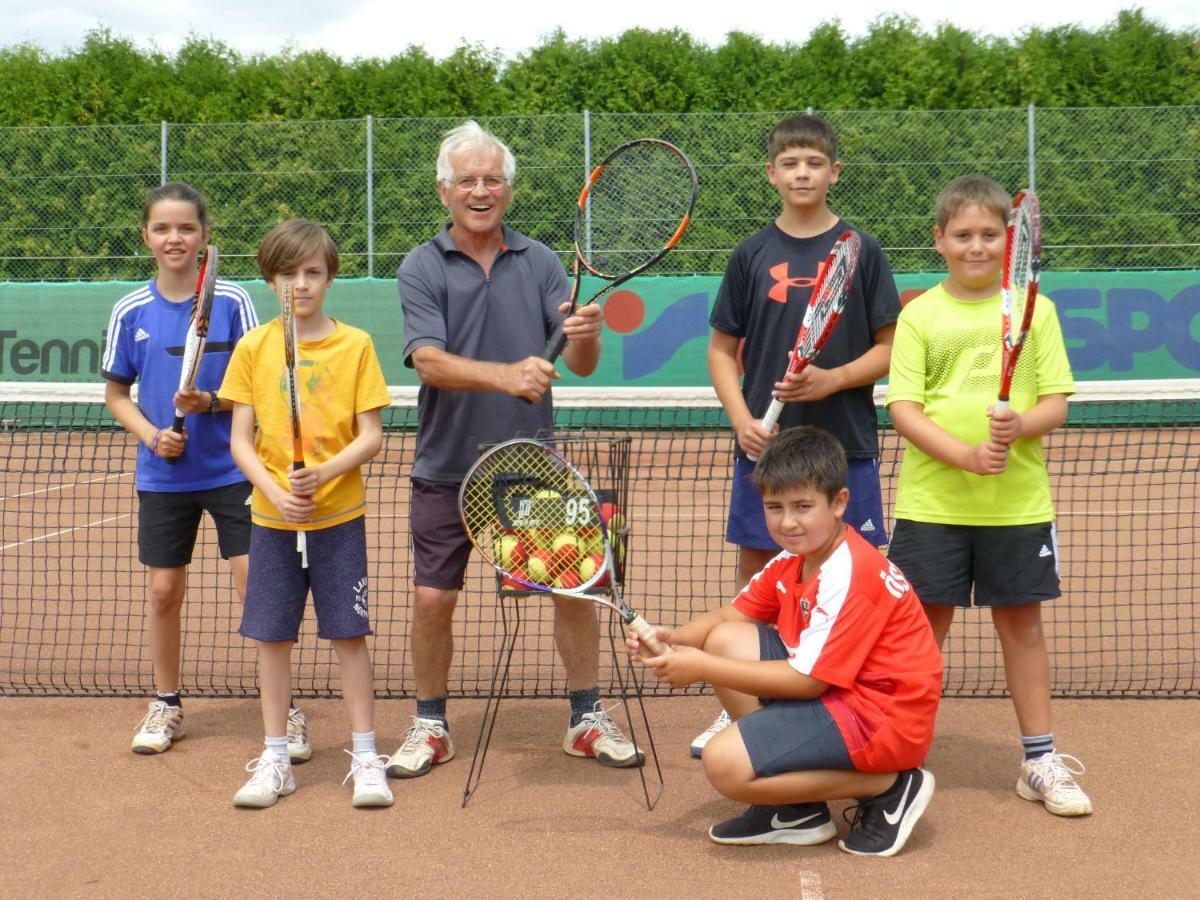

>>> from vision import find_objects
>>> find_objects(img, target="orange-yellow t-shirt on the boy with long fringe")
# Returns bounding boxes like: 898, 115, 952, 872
220, 318, 389, 532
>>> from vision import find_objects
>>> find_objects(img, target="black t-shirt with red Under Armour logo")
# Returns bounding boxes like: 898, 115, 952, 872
708, 220, 900, 460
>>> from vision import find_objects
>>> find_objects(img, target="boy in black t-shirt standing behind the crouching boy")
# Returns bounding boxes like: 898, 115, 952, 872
692, 115, 900, 756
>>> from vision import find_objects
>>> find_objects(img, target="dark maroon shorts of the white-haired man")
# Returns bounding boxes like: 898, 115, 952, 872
408, 478, 473, 590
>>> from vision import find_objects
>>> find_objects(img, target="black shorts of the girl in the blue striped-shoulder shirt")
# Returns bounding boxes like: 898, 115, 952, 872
138, 481, 250, 569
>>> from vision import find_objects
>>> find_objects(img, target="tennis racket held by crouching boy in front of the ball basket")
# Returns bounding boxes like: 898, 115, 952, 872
458, 439, 671, 655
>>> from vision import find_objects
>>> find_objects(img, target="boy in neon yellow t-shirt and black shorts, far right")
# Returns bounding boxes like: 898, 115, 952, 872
888, 175, 1092, 816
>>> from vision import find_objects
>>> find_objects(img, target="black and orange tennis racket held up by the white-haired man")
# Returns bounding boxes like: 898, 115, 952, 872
542, 138, 700, 362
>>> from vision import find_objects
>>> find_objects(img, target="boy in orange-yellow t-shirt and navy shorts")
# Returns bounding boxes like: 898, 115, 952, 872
220, 220, 392, 808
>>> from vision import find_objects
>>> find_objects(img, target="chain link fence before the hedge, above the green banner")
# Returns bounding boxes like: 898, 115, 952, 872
0, 107, 1200, 281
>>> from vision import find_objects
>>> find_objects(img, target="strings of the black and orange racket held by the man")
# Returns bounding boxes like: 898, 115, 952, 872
577, 144, 694, 274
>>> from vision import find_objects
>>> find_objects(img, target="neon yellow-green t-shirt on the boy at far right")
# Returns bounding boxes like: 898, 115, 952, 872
888, 284, 1075, 526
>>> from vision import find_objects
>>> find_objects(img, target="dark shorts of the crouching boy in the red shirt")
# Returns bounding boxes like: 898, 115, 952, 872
737, 624, 854, 778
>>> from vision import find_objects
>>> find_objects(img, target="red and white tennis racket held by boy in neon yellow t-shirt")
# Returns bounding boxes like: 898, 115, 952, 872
995, 191, 1042, 409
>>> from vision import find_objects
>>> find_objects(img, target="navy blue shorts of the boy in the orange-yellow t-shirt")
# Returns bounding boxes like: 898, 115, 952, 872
238, 516, 371, 642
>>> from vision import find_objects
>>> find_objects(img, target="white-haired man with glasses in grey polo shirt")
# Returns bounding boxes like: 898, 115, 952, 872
388, 121, 643, 778
